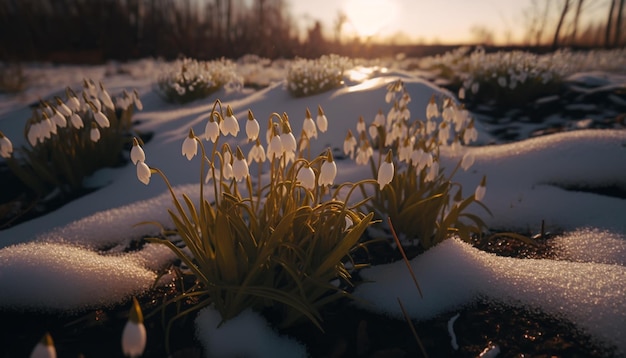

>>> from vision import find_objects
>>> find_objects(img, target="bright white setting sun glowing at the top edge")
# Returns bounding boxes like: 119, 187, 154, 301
338, 0, 398, 37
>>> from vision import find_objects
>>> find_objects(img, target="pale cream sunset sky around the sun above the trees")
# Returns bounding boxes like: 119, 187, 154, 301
289, 0, 601, 44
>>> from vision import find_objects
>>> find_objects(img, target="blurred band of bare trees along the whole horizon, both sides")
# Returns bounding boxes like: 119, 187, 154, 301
0, 0, 626, 64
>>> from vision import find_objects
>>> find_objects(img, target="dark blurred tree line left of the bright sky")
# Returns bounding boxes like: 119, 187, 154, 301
0, 0, 332, 61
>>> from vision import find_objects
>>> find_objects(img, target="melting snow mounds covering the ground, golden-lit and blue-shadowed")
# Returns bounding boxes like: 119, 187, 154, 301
0, 60, 626, 357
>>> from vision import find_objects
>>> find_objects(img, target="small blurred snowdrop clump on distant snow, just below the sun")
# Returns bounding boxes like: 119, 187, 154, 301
287, 54, 352, 97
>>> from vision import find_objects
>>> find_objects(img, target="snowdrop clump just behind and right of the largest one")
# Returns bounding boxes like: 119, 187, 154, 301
344, 80, 489, 249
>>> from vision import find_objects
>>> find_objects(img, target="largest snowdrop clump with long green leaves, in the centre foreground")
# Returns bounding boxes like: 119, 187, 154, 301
131, 100, 373, 336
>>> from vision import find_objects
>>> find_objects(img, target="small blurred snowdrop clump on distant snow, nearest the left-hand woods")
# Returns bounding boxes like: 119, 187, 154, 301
157, 58, 243, 103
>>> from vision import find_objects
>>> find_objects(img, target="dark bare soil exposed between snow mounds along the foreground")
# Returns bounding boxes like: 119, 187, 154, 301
0, 233, 617, 358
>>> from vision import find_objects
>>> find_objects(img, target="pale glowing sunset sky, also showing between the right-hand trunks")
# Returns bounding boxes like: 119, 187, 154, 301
286, 0, 608, 45
